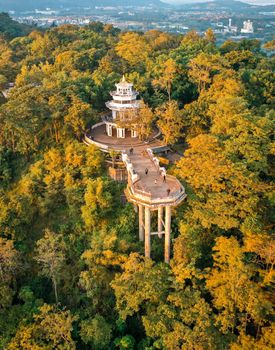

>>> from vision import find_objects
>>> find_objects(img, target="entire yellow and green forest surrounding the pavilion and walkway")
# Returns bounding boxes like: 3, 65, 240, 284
0, 13, 275, 350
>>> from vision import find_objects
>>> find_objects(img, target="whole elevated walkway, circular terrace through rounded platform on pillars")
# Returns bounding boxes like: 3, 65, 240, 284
84, 122, 186, 263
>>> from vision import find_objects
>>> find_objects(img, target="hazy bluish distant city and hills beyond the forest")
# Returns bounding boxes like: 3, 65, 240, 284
0, 0, 275, 42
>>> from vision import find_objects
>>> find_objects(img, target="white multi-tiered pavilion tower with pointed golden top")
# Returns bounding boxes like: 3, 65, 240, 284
104, 75, 140, 138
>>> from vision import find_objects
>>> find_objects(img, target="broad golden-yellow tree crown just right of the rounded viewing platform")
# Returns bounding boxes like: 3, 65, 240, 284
177, 134, 267, 229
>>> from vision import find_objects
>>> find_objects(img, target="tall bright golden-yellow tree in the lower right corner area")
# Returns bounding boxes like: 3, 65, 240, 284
206, 237, 271, 333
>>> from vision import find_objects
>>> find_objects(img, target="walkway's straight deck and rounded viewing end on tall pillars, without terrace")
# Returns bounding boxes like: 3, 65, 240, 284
122, 147, 186, 263
